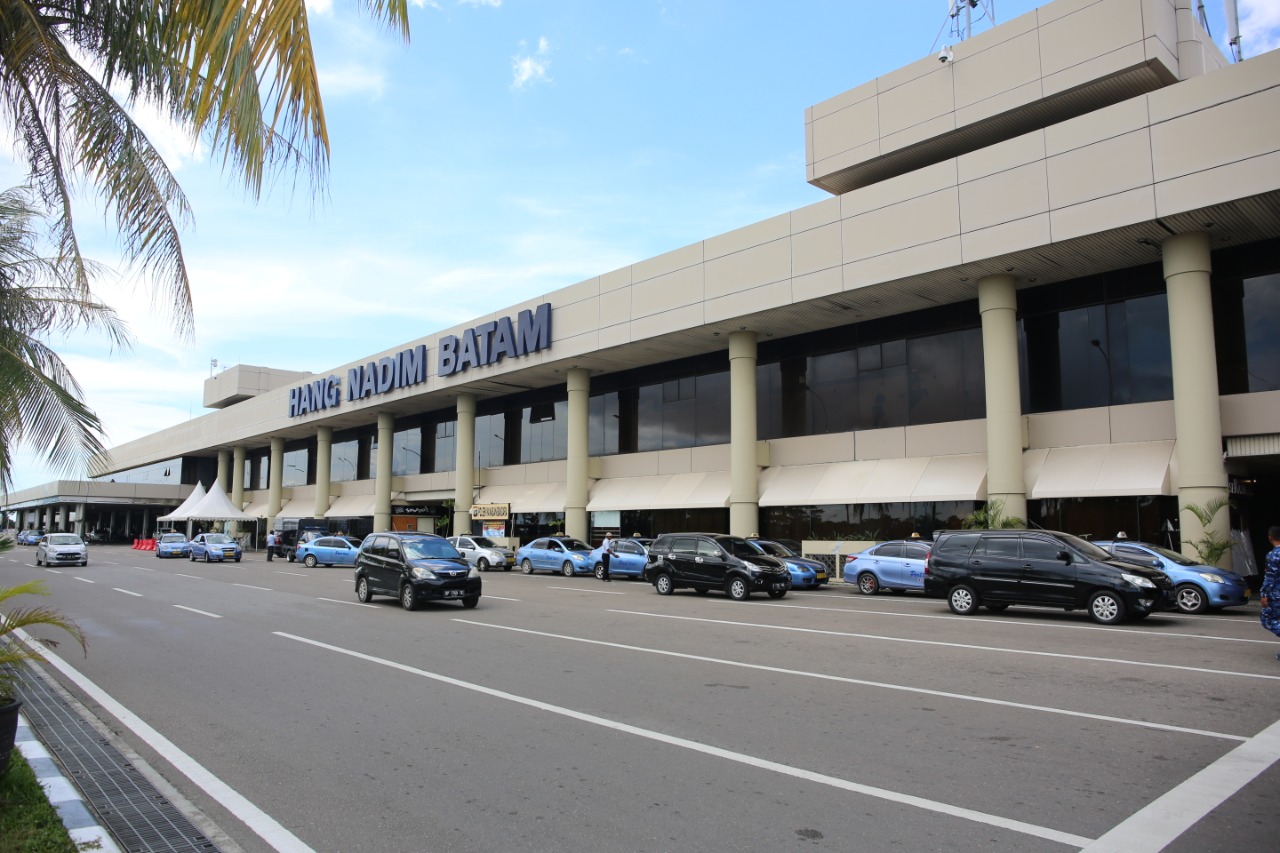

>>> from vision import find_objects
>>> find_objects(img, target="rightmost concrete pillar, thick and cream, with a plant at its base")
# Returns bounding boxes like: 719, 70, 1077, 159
1162, 233, 1231, 569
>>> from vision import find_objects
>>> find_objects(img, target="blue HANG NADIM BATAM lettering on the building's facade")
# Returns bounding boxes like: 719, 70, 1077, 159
289, 302, 552, 418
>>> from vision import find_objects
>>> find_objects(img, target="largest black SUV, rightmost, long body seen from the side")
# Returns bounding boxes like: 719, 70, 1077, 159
924, 530, 1174, 625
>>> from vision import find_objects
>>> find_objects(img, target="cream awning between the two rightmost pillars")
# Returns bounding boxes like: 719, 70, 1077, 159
1024, 441, 1174, 500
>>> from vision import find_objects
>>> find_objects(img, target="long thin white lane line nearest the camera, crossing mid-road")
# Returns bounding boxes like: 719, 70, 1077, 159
273, 631, 1092, 847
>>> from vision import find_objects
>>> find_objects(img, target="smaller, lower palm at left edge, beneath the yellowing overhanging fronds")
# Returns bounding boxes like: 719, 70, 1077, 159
0, 187, 128, 492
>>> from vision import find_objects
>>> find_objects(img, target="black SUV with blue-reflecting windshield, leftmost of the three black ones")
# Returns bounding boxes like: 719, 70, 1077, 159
356, 533, 481, 610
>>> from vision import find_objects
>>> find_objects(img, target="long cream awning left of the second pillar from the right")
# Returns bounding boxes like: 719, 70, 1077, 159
760, 453, 987, 506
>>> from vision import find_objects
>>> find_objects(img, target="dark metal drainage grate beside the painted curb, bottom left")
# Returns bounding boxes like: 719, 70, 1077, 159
22, 671, 218, 853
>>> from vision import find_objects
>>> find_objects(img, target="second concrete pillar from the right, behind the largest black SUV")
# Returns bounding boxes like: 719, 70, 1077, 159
978, 275, 1027, 519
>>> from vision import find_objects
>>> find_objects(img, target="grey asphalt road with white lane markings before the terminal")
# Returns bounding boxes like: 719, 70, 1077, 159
0, 546, 1280, 853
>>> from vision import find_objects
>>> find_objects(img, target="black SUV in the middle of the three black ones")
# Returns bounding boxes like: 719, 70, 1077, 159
644, 533, 791, 601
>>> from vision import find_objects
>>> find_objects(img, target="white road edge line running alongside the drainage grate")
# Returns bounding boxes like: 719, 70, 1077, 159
18, 622, 315, 853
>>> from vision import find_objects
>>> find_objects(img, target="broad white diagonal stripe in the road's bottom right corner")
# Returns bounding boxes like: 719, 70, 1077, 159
1084, 721, 1280, 853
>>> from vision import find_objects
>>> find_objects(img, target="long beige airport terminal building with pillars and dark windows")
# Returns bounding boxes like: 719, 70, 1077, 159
8, 0, 1280, 573
